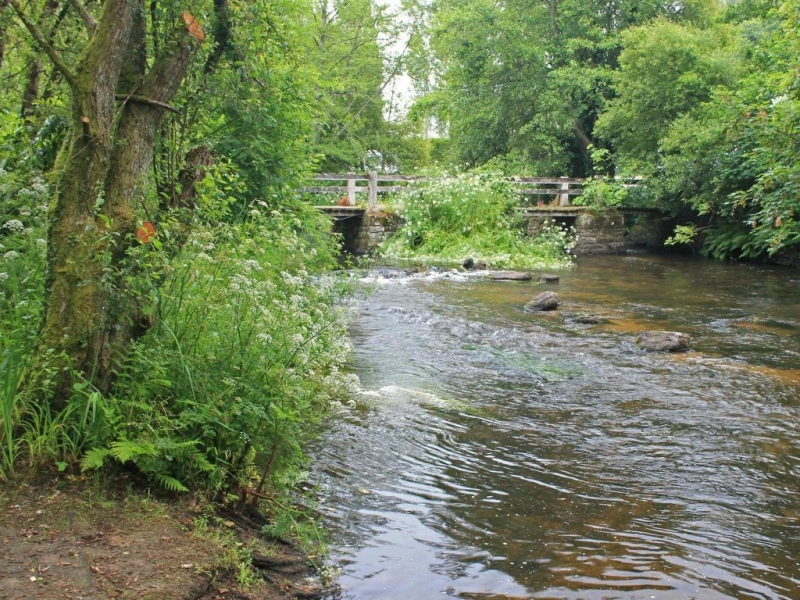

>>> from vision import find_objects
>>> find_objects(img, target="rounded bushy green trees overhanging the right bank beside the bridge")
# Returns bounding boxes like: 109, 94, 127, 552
596, 1, 800, 260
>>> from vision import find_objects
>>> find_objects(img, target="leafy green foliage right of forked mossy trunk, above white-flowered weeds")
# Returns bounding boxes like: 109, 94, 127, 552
195, 1, 316, 209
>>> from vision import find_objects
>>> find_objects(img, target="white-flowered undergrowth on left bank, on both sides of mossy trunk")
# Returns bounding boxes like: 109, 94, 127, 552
0, 161, 355, 510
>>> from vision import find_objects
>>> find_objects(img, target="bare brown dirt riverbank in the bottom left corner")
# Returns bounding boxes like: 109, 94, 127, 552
0, 476, 328, 600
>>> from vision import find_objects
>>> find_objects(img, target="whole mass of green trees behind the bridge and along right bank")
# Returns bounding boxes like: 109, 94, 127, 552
412, 0, 800, 258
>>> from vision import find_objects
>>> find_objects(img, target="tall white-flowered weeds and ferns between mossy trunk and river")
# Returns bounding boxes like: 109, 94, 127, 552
83, 197, 356, 491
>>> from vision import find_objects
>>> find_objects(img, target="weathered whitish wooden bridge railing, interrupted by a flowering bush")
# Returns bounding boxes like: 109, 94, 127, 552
300, 171, 587, 208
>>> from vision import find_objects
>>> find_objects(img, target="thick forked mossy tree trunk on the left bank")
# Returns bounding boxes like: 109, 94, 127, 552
9, 0, 203, 410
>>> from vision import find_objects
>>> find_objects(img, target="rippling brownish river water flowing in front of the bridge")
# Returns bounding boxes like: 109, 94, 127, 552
313, 255, 800, 600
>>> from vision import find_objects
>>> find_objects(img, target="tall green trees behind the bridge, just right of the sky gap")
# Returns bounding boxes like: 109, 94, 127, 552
412, 0, 718, 176
